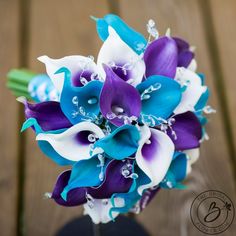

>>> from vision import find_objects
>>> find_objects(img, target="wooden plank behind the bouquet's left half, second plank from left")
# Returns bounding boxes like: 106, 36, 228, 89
25, 0, 107, 236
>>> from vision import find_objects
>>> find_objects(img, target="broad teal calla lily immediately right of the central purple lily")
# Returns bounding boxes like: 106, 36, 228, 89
137, 76, 181, 124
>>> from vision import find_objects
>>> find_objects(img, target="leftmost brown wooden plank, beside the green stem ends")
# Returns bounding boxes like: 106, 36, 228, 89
0, 0, 19, 236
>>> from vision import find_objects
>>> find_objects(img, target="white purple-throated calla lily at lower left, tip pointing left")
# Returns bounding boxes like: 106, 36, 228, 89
36, 122, 104, 161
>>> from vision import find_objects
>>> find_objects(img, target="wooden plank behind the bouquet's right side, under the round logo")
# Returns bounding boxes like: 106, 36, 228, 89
120, 0, 236, 236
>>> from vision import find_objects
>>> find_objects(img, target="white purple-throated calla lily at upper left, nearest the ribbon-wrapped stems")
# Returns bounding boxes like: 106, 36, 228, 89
38, 56, 98, 93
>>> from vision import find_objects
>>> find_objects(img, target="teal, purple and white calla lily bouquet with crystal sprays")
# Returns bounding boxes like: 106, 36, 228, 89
9, 14, 214, 223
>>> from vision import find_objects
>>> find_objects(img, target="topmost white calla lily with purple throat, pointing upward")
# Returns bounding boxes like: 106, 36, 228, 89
97, 27, 145, 86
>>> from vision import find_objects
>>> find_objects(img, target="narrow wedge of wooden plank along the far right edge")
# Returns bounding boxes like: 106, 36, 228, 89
209, 0, 236, 159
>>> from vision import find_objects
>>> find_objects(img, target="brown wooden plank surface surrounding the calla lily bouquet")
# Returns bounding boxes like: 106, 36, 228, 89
0, 0, 236, 236
